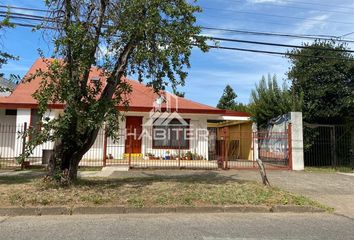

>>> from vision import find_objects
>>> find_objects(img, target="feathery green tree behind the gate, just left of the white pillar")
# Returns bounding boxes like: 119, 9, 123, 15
249, 75, 301, 127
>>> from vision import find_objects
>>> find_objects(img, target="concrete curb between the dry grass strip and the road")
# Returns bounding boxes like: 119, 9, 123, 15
0, 205, 325, 216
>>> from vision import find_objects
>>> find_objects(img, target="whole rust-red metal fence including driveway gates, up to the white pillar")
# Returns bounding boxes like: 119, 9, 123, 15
0, 125, 291, 169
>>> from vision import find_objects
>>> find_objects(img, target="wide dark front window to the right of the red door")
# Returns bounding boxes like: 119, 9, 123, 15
153, 119, 189, 149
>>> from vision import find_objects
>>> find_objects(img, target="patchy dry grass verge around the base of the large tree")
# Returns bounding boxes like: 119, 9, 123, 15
0, 172, 325, 208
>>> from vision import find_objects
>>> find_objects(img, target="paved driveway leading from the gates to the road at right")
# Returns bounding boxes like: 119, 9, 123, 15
223, 171, 354, 218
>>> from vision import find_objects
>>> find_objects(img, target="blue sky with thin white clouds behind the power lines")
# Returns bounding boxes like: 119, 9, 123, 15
0, 0, 354, 106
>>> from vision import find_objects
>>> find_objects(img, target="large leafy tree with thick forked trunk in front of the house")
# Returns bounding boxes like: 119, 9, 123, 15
24, 0, 208, 182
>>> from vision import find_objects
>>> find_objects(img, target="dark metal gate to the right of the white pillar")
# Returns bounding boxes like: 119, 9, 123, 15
304, 124, 354, 168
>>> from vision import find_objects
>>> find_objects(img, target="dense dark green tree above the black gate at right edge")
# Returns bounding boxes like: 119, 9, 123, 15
288, 40, 354, 123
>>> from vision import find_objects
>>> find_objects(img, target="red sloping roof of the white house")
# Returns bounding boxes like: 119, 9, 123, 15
0, 58, 249, 117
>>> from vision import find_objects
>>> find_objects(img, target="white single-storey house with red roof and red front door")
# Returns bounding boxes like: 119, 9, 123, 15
0, 59, 252, 169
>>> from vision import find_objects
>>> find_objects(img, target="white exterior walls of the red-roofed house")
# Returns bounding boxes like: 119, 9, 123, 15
0, 109, 208, 161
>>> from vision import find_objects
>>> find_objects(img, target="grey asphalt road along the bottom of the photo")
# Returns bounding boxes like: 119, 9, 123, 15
0, 213, 354, 240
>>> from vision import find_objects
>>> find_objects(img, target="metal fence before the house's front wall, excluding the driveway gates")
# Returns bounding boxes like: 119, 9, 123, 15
0, 125, 221, 169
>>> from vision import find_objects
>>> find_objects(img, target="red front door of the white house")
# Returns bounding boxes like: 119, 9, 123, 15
125, 116, 143, 153
